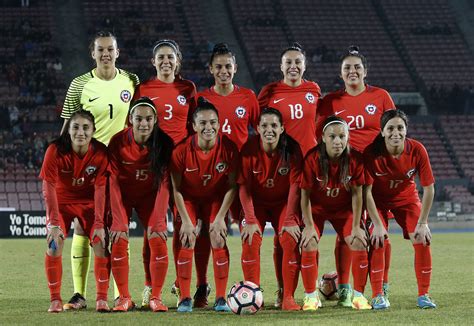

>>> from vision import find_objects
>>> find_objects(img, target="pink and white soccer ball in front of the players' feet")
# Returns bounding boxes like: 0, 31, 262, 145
227, 281, 263, 315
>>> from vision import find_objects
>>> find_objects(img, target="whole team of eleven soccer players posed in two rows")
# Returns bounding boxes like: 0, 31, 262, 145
40, 32, 436, 312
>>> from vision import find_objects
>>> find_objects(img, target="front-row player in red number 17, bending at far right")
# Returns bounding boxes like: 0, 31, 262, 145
364, 110, 436, 308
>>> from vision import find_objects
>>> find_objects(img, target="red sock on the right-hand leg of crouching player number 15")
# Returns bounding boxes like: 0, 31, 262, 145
148, 237, 168, 298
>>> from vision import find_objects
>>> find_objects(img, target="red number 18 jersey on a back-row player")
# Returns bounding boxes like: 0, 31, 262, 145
258, 80, 321, 155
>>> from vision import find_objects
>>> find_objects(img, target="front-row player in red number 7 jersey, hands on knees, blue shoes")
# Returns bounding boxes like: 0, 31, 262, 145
171, 97, 239, 312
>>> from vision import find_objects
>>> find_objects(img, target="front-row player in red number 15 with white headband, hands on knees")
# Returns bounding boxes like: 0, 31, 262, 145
109, 97, 173, 312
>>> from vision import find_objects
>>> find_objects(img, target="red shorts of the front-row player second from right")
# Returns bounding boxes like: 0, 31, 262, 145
313, 210, 353, 239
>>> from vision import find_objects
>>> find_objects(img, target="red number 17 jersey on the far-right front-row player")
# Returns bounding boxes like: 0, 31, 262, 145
364, 138, 434, 209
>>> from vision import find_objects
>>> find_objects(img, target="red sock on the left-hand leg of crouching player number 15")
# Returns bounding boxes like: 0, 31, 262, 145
111, 239, 130, 298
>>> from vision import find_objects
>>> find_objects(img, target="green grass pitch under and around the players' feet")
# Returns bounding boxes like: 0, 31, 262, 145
0, 233, 474, 325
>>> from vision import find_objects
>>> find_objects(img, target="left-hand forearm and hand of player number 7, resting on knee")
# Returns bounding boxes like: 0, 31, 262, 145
171, 171, 196, 248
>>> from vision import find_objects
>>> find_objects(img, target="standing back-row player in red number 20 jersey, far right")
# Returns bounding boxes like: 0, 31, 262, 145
317, 46, 395, 307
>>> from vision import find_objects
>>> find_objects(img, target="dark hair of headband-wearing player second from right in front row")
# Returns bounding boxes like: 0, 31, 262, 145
316, 115, 350, 190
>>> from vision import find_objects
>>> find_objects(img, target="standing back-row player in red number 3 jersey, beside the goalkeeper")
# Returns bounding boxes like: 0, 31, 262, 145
135, 39, 196, 306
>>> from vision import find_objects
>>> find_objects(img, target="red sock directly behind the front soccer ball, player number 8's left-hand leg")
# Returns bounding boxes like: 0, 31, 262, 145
241, 233, 262, 286
